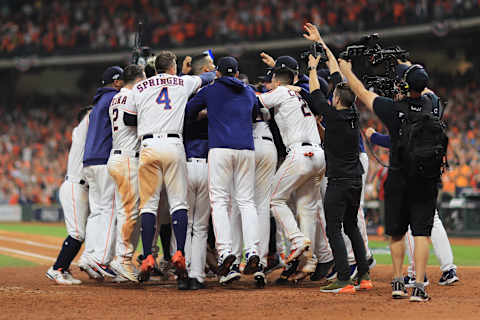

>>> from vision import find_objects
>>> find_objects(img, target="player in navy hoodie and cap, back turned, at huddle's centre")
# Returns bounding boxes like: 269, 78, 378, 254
187, 57, 260, 276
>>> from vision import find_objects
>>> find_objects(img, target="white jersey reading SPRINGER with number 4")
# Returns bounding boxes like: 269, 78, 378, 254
133, 73, 202, 137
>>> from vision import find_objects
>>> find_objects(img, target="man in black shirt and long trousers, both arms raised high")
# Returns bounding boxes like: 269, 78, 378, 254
305, 24, 373, 293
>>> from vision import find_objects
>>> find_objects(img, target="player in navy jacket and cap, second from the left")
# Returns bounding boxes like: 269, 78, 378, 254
80, 66, 123, 278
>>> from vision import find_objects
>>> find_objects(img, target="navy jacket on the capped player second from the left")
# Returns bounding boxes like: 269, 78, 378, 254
83, 88, 118, 167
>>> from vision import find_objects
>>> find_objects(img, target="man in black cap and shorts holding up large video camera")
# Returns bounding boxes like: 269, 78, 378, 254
339, 55, 439, 301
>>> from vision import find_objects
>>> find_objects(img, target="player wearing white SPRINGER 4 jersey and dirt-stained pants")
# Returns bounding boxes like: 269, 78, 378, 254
133, 51, 215, 289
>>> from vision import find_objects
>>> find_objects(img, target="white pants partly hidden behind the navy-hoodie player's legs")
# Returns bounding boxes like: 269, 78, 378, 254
230, 137, 277, 267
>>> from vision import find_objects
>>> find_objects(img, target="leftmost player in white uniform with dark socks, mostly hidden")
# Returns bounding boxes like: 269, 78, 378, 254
46, 106, 95, 284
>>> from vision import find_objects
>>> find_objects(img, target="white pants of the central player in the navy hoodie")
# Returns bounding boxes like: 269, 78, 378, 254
208, 148, 259, 256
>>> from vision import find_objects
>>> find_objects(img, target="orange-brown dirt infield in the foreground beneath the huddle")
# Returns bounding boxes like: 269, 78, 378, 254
0, 266, 480, 320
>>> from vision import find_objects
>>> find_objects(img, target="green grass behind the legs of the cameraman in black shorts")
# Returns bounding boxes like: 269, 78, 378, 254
368, 241, 480, 266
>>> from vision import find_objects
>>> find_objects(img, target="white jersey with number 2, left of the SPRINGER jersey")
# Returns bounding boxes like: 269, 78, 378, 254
108, 88, 140, 151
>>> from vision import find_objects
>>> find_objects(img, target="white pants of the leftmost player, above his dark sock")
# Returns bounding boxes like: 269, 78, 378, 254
58, 176, 90, 242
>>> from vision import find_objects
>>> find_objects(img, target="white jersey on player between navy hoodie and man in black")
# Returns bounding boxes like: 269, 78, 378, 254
258, 86, 320, 148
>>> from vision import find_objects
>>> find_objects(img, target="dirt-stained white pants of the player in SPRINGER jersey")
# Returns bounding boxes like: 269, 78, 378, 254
138, 137, 188, 214
